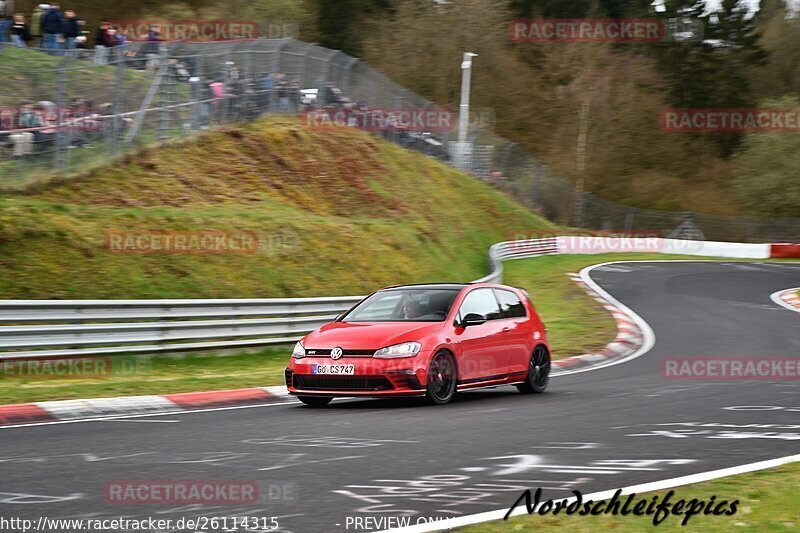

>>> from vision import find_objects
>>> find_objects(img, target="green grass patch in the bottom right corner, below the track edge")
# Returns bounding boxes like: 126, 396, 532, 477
456, 463, 800, 533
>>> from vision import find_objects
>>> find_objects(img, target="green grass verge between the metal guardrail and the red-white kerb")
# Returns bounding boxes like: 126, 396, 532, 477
6, 254, 792, 404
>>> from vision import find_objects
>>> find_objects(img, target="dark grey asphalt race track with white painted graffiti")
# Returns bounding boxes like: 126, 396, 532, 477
0, 262, 800, 532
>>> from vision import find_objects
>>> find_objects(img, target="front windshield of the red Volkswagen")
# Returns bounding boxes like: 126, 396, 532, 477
342, 288, 460, 322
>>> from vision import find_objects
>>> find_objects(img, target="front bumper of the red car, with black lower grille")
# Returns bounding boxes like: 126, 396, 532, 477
285, 353, 428, 396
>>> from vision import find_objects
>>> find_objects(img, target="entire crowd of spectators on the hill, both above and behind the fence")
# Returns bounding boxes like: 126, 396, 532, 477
0, 10, 444, 157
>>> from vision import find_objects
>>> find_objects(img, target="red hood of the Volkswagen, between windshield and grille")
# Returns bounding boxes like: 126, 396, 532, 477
303, 322, 444, 350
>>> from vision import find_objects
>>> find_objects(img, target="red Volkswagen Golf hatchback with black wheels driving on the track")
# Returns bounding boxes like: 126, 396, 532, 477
286, 283, 550, 406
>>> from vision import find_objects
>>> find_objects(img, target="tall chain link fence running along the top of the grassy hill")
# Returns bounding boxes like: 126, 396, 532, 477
0, 38, 800, 242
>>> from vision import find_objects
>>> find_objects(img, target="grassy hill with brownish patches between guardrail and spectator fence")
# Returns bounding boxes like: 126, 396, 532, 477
0, 118, 549, 299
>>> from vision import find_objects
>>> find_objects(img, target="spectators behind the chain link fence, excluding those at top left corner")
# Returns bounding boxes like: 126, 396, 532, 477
0, 64, 443, 157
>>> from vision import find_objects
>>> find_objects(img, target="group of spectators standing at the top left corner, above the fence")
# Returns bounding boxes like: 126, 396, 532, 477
0, 0, 87, 51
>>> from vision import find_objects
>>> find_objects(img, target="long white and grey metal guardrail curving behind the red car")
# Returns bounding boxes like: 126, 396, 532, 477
0, 236, 770, 360
